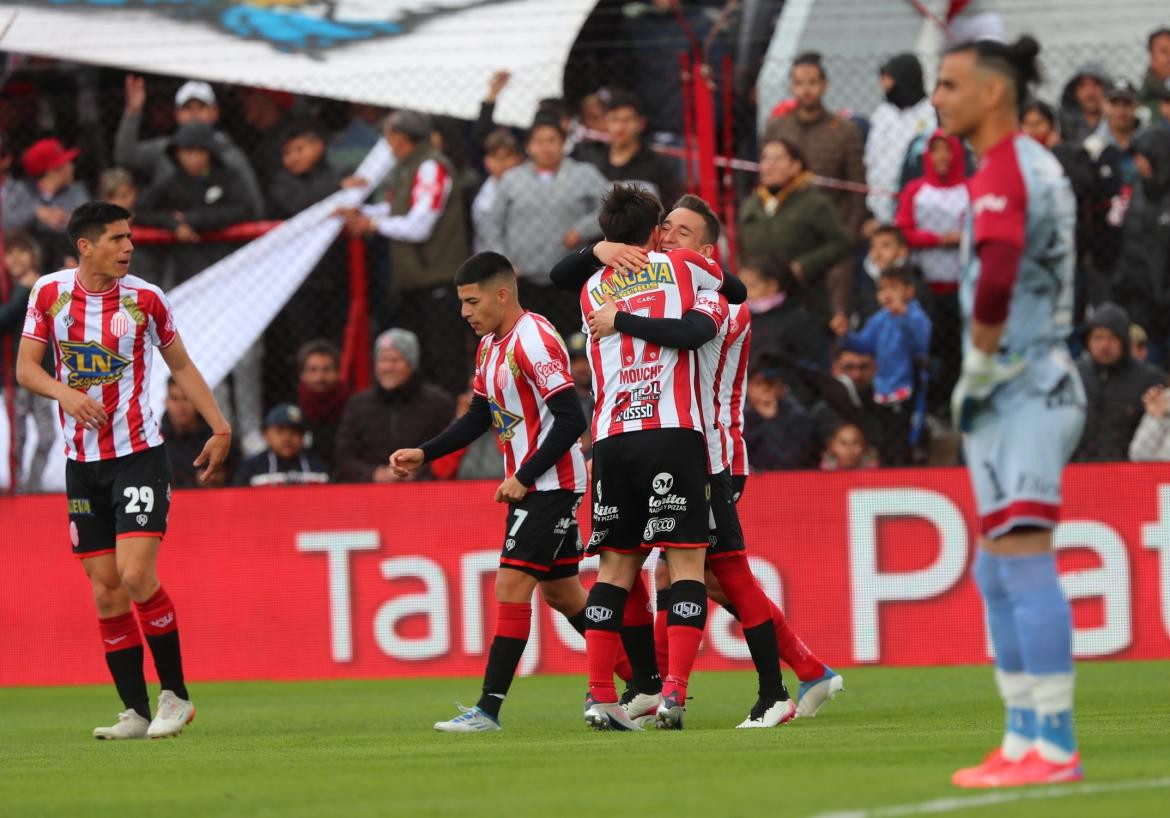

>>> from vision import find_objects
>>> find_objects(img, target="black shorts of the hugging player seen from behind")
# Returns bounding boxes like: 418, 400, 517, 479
586, 428, 710, 554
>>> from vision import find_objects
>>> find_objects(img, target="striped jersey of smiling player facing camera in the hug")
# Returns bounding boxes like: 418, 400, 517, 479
695, 291, 751, 475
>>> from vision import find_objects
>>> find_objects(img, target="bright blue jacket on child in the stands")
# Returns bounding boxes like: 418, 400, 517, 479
844, 300, 930, 404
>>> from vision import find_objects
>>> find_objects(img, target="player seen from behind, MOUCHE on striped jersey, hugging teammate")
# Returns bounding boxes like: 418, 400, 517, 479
563, 186, 742, 730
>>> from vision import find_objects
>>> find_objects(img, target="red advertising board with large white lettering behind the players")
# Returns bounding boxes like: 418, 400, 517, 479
0, 465, 1170, 685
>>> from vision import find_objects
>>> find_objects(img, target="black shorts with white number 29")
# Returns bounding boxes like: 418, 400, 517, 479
66, 446, 171, 557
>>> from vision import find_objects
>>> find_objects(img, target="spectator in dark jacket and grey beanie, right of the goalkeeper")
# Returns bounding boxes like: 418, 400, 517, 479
1073, 302, 1165, 462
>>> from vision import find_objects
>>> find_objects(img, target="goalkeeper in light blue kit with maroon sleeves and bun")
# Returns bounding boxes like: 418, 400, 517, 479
934, 36, 1086, 786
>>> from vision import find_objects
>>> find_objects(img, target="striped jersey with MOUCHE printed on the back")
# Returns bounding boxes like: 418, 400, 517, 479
580, 249, 723, 442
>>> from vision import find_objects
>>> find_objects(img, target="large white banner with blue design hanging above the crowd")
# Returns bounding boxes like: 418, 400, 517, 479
0, 0, 596, 125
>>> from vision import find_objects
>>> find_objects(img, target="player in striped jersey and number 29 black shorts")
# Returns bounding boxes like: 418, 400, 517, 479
16, 201, 232, 738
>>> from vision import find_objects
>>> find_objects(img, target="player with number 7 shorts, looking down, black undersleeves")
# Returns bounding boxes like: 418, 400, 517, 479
390, 253, 594, 733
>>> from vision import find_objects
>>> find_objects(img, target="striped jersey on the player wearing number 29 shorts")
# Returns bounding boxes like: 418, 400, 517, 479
23, 269, 178, 462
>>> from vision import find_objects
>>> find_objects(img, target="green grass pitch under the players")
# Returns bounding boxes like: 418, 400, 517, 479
0, 662, 1170, 818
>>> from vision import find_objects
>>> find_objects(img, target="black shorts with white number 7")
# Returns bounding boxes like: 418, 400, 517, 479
500, 489, 584, 580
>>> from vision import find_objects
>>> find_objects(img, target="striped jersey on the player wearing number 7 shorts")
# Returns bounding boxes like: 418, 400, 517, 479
473, 312, 587, 493
